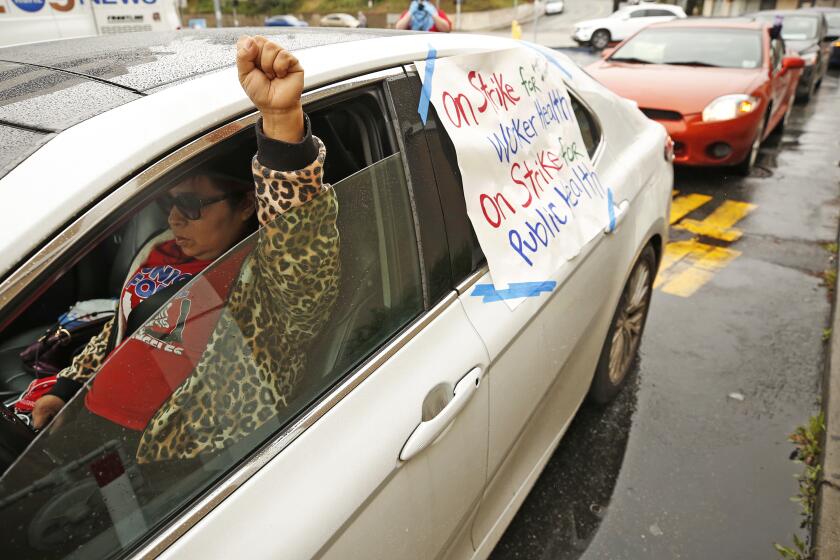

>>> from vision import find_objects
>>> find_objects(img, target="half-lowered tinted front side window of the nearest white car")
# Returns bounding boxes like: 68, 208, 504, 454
0, 89, 423, 558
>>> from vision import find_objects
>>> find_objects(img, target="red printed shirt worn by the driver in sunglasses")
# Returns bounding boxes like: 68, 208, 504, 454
85, 242, 250, 430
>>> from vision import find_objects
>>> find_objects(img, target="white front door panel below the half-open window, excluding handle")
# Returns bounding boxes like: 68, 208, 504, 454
163, 296, 487, 559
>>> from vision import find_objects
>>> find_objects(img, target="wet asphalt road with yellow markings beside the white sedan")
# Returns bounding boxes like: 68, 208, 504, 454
492, 50, 840, 560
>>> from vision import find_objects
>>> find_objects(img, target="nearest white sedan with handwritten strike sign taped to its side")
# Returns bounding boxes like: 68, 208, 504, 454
0, 29, 673, 560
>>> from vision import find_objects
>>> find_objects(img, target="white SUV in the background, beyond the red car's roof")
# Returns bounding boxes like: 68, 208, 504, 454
572, 3, 686, 49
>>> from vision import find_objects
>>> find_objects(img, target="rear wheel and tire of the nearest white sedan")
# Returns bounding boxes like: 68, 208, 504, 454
589, 245, 656, 404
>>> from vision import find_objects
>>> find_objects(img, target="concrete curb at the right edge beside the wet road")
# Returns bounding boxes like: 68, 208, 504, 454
814, 252, 840, 560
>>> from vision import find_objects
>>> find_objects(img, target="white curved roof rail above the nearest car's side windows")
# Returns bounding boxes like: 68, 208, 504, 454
0, 29, 568, 282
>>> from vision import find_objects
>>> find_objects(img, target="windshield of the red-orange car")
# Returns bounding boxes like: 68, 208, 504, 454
610, 28, 761, 68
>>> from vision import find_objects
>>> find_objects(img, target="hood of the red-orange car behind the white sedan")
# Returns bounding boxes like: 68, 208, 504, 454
586, 60, 766, 115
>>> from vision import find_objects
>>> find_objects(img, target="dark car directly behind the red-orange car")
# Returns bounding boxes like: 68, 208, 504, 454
752, 10, 831, 101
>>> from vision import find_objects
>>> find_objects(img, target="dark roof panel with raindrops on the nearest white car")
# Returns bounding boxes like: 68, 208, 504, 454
0, 28, 396, 178
